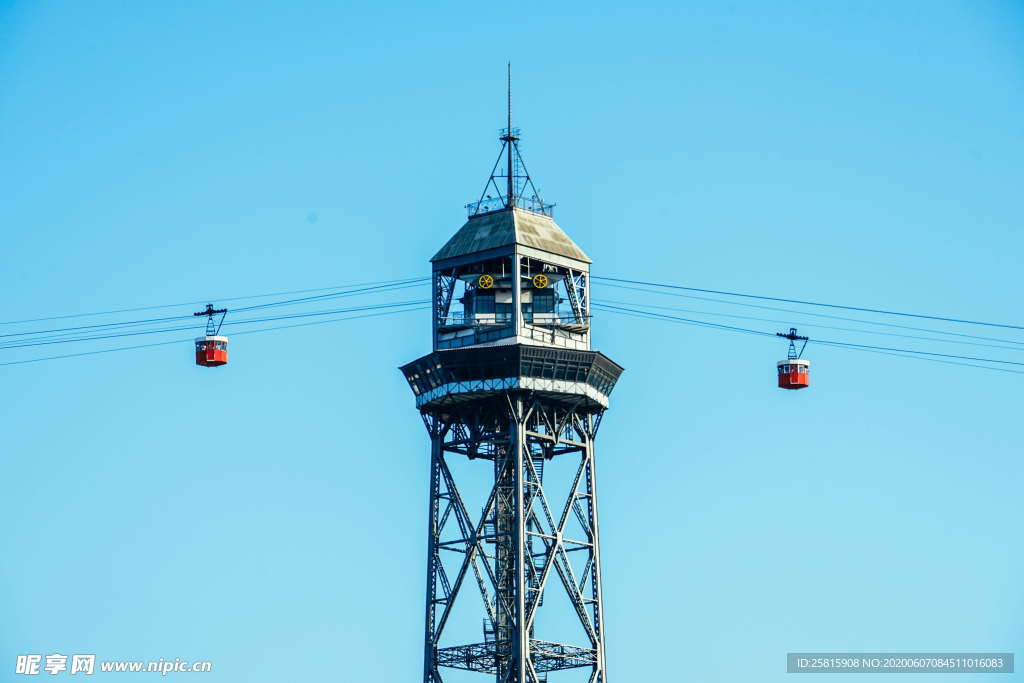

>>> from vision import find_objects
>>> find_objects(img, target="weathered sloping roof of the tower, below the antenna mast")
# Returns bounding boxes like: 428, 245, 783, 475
430, 207, 591, 263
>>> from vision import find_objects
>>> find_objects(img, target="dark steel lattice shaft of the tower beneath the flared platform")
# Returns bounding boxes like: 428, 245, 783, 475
423, 391, 606, 683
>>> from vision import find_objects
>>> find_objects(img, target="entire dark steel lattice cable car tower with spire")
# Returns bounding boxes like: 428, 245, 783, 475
401, 70, 623, 683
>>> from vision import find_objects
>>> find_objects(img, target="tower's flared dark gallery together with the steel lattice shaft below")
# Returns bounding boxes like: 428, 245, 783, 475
401, 344, 623, 683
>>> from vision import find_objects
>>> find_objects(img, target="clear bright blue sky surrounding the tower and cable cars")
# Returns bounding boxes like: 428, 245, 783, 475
0, 0, 1024, 683
